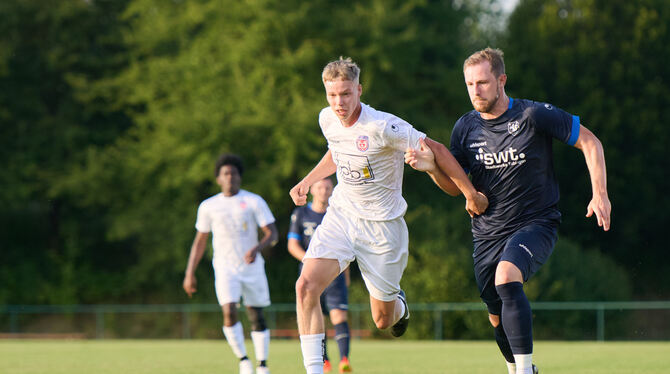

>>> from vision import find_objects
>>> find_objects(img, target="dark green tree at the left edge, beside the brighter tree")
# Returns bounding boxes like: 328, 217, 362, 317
0, 0, 131, 304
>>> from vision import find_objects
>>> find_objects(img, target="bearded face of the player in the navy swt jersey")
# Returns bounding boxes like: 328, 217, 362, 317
463, 61, 505, 113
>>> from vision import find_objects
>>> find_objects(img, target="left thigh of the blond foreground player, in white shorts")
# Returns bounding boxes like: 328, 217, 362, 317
303, 207, 355, 271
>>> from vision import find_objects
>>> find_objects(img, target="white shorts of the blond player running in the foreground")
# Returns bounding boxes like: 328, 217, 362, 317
303, 206, 409, 301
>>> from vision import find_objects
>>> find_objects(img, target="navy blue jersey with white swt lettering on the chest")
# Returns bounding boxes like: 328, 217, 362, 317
451, 98, 580, 238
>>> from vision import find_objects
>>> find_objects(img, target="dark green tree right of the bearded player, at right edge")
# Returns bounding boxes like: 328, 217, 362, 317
504, 0, 670, 298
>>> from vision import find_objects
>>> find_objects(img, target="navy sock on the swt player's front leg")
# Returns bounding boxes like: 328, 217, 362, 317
496, 282, 533, 356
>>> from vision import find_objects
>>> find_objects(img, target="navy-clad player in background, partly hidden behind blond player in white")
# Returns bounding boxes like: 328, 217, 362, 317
288, 178, 351, 373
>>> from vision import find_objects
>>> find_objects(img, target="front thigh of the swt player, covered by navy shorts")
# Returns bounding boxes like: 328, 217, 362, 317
500, 223, 558, 282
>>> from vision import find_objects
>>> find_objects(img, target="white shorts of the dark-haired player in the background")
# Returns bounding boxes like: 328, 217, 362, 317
213, 265, 270, 308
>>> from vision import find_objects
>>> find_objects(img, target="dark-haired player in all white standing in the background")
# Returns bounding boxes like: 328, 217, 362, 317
183, 154, 277, 374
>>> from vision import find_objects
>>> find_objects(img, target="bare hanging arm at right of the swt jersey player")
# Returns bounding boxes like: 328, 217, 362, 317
575, 125, 612, 231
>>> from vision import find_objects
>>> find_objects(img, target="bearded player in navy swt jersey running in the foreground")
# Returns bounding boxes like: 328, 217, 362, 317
405, 48, 611, 374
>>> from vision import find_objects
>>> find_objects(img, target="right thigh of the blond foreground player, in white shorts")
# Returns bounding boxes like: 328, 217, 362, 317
354, 218, 409, 302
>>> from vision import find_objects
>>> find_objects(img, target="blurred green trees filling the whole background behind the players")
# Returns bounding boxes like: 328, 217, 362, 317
0, 0, 670, 337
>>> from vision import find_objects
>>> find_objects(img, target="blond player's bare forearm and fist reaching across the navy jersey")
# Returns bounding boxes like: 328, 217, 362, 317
422, 137, 489, 217
